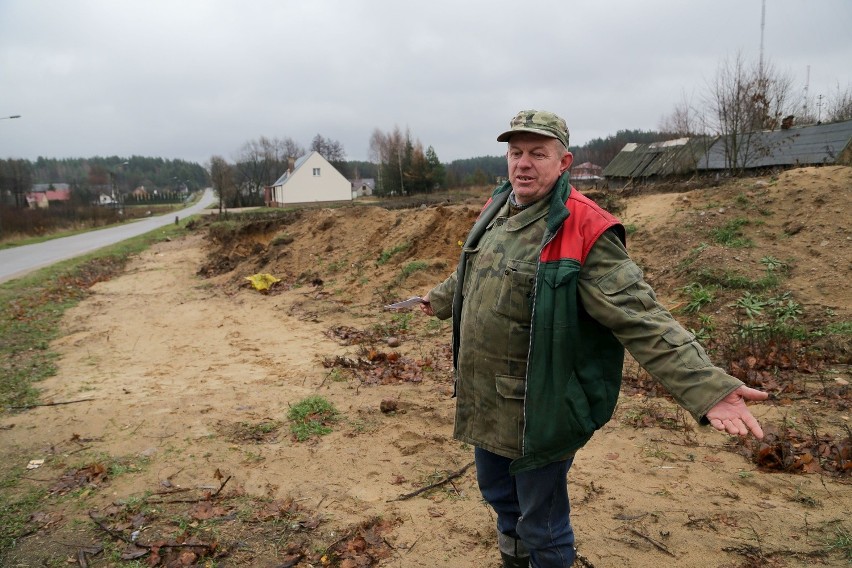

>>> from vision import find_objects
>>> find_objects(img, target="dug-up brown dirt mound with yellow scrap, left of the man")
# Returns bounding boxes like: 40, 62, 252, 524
199, 205, 479, 301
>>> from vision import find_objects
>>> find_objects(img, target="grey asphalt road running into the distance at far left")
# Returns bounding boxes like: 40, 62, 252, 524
0, 189, 216, 282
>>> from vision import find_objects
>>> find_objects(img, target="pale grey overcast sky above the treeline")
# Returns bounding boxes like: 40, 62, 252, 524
0, 0, 852, 164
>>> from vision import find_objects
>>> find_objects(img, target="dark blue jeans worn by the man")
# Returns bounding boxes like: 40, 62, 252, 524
474, 448, 575, 568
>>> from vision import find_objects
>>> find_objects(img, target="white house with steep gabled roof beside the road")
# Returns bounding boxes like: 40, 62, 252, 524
267, 152, 352, 207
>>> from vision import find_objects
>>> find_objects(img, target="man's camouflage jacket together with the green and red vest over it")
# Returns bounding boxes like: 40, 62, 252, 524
430, 175, 741, 472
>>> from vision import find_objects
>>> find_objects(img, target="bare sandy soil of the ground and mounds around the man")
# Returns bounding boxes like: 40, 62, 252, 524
0, 168, 852, 568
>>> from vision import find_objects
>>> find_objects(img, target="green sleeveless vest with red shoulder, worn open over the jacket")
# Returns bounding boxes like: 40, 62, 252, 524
446, 174, 624, 473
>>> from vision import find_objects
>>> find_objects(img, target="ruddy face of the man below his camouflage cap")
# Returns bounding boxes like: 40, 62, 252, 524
506, 132, 574, 205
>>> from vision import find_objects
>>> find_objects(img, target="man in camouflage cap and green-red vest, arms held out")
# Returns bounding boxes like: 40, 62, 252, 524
421, 110, 767, 568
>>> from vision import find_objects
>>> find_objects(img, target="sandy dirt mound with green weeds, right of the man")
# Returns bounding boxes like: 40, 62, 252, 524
624, 166, 852, 319
